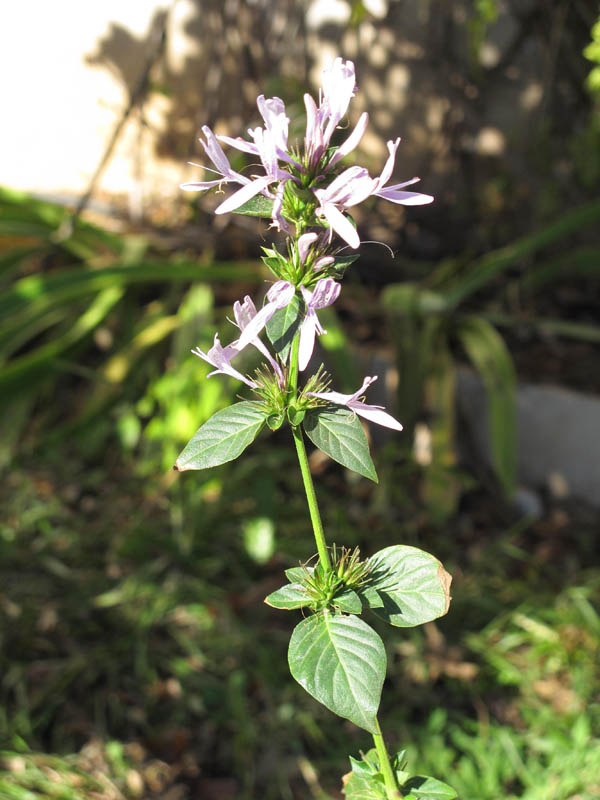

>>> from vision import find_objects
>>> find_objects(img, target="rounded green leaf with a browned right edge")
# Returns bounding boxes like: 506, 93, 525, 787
359, 544, 452, 628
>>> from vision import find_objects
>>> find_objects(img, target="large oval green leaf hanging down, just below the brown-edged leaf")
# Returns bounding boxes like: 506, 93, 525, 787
288, 612, 386, 733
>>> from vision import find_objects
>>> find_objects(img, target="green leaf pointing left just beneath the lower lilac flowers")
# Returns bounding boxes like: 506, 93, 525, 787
174, 401, 265, 472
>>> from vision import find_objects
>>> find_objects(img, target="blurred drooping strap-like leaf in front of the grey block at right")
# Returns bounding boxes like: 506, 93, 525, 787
457, 315, 517, 497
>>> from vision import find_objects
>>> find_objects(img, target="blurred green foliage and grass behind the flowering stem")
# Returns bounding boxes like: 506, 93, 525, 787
0, 0, 600, 800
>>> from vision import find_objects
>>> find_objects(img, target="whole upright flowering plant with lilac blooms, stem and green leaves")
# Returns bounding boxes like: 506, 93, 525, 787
175, 58, 456, 800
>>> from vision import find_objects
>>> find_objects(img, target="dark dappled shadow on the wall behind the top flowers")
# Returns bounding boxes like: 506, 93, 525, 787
88, 0, 597, 258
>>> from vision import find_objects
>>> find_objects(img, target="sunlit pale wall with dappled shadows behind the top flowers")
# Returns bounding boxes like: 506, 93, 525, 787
0, 0, 586, 241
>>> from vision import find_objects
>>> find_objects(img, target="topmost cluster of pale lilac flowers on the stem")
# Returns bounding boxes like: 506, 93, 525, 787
182, 58, 433, 245
